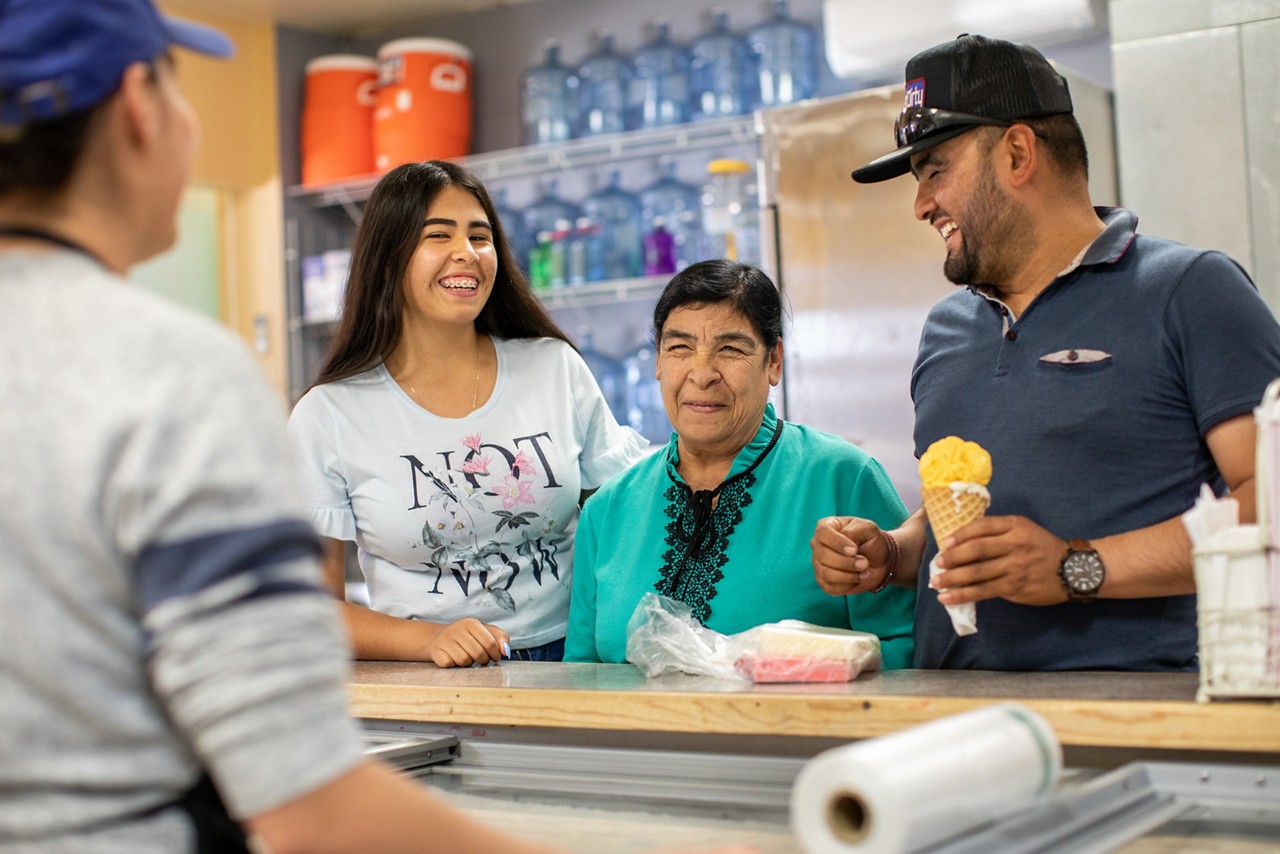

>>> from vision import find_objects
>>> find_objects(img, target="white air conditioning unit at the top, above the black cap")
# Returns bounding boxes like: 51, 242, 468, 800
822, 0, 1106, 77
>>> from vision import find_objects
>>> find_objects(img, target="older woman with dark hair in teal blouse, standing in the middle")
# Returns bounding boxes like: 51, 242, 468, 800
564, 260, 915, 668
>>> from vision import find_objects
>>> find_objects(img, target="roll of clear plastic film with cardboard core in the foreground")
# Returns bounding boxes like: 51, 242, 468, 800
791, 703, 1062, 854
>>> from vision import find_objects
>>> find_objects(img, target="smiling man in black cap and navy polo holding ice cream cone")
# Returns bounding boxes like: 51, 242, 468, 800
812, 35, 1280, 671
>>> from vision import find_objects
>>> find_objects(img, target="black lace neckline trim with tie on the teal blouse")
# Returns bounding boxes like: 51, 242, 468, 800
654, 419, 783, 624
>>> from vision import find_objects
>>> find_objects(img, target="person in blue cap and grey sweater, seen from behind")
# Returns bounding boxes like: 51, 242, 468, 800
0, 0, 757, 854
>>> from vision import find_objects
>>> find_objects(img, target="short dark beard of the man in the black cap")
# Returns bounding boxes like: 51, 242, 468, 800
942, 168, 1021, 291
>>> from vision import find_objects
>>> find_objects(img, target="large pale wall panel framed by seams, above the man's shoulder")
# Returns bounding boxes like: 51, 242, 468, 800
1112, 28, 1252, 269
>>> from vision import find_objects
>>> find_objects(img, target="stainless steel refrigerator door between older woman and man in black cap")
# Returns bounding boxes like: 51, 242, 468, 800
762, 86, 952, 508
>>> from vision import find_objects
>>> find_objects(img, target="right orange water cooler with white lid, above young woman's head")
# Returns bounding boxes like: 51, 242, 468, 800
374, 38, 471, 172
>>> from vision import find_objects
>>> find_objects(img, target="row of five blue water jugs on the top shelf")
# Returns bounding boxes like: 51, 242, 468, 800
522, 0, 820, 145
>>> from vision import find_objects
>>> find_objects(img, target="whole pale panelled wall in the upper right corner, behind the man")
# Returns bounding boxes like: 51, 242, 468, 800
1110, 0, 1280, 310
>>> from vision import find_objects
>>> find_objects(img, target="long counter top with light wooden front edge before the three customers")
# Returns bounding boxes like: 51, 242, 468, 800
348, 661, 1280, 754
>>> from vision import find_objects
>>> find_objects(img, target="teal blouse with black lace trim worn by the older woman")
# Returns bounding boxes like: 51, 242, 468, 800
564, 405, 915, 670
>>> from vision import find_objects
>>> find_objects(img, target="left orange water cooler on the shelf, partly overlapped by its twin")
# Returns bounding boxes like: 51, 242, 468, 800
302, 54, 378, 184
